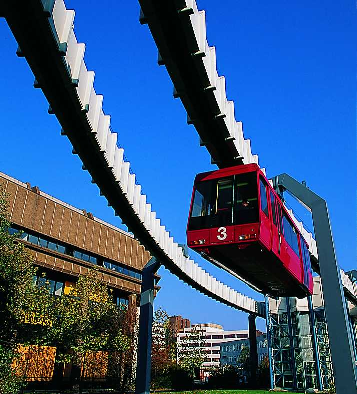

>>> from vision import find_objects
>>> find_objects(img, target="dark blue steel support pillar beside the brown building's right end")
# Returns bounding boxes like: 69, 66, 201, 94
135, 257, 161, 394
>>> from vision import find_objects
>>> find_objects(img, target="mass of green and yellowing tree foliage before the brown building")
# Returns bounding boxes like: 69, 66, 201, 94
0, 189, 136, 394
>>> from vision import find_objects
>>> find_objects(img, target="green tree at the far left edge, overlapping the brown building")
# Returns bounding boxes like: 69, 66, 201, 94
0, 188, 53, 394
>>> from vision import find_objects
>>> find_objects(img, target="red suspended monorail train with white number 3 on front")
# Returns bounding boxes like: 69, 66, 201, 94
187, 164, 313, 298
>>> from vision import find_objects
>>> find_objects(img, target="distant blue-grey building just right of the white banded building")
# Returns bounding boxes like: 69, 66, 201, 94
220, 332, 268, 366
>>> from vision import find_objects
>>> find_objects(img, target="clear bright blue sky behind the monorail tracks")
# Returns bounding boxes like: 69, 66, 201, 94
0, 0, 356, 329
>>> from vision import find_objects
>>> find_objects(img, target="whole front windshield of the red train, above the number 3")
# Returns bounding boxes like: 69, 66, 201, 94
188, 172, 259, 230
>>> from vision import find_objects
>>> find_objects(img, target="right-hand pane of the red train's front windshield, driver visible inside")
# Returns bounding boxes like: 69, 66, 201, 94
234, 172, 259, 224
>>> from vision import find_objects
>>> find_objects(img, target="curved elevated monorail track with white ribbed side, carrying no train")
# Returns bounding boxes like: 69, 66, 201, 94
3, 0, 264, 316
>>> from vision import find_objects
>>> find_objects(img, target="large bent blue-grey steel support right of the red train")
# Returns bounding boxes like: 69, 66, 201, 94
273, 174, 357, 394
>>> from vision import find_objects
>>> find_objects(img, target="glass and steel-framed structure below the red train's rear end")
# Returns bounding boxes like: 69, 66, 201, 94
268, 276, 357, 390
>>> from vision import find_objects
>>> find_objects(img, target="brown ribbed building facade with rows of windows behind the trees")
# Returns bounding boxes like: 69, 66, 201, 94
0, 173, 153, 380
